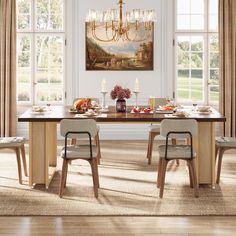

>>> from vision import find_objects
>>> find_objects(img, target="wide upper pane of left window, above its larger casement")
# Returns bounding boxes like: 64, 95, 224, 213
36, 0, 64, 30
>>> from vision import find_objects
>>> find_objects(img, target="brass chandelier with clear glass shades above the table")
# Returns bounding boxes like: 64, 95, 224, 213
86, 0, 156, 42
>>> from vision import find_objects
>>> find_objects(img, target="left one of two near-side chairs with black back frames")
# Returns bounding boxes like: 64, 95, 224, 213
59, 119, 99, 198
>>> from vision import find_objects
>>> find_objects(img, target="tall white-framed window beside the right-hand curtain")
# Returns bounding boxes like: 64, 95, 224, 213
175, 0, 219, 104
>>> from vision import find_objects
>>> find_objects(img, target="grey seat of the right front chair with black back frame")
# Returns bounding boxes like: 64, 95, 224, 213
158, 145, 196, 159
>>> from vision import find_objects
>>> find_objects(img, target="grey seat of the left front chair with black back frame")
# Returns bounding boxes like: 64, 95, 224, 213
61, 145, 97, 159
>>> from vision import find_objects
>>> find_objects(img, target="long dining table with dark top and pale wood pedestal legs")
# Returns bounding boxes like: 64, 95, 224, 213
18, 106, 226, 187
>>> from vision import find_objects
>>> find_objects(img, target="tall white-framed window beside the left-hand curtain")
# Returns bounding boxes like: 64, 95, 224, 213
17, 0, 65, 104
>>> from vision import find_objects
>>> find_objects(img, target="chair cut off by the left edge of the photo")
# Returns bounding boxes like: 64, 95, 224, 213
0, 137, 28, 184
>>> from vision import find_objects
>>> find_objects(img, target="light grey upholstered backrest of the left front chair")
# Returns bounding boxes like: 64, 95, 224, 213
60, 119, 98, 138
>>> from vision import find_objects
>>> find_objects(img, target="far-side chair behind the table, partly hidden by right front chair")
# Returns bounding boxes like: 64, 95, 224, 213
147, 98, 179, 165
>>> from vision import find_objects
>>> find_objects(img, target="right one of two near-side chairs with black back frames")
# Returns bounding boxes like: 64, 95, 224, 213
157, 119, 199, 198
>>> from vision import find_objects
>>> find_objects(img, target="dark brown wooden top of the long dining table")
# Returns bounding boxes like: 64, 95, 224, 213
18, 106, 226, 123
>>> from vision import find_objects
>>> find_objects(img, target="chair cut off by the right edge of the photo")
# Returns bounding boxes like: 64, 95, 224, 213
216, 137, 236, 184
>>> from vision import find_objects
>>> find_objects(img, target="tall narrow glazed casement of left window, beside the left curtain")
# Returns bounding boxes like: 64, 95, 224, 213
17, 35, 31, 102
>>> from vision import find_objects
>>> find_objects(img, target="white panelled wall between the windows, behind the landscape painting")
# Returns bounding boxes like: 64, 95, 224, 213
63, 0, 174, 139
